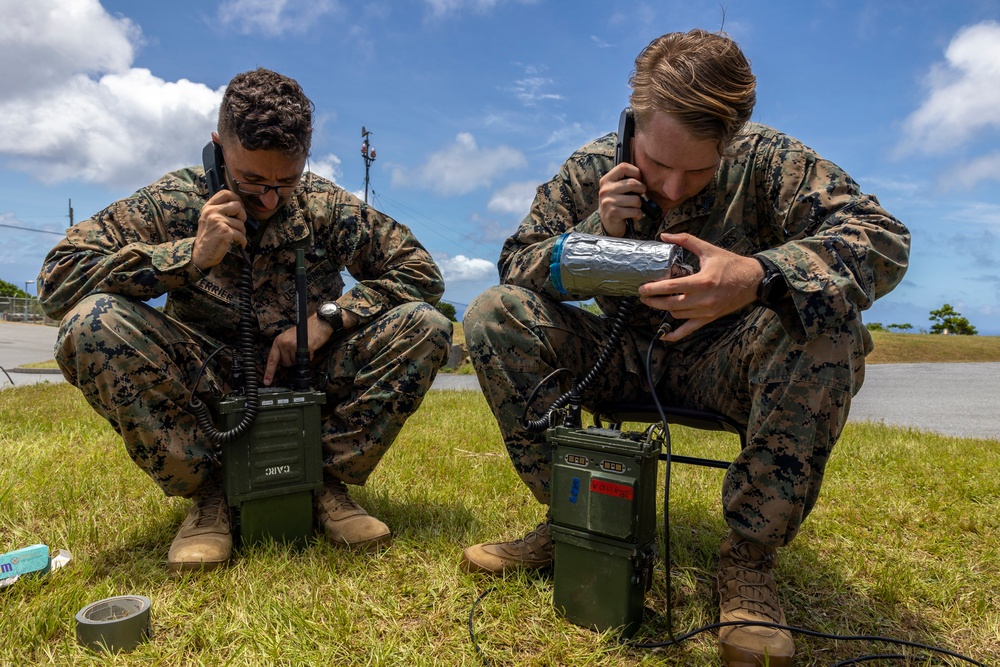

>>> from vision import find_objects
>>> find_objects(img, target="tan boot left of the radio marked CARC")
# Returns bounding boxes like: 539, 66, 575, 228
167, 484, 233, 572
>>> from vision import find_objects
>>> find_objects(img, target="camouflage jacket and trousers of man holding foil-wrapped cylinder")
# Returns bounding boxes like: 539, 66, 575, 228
464, 124, 909, 546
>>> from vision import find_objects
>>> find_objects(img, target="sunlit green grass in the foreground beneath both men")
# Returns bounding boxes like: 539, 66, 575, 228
0, 384, 1000, 666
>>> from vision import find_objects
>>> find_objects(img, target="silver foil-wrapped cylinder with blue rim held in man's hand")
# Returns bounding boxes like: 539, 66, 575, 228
549, 232, 693, 298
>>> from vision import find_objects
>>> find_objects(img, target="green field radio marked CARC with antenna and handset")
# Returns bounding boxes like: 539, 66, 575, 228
191, 143, 326, 545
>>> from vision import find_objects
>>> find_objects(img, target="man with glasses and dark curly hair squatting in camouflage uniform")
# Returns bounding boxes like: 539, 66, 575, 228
38, 68, 451, 572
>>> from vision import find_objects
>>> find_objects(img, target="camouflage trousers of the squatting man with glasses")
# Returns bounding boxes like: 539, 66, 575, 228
56, 294, 451, 496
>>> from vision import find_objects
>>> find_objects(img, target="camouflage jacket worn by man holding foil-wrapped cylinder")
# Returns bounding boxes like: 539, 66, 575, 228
498, 124, 910, 341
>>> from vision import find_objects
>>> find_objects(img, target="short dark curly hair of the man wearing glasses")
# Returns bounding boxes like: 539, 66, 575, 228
219, 67, 314, 157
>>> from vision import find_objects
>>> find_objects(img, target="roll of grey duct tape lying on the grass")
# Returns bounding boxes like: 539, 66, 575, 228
76, 595, 149, 652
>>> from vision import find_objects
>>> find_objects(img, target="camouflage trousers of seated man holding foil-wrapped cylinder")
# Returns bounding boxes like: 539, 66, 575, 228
463, 285, 871, 546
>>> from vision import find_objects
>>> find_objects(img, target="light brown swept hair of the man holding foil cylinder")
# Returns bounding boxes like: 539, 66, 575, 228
629, 30, 757, 153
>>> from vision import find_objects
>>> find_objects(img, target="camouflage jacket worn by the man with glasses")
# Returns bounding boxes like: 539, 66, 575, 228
38, 167, 444, 353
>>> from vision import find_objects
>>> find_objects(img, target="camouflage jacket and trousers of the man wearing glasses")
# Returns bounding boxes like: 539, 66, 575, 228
38, 168, 451, 496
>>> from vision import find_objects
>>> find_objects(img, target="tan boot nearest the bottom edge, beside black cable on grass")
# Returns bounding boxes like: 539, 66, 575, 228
718, 532, 795, 667
